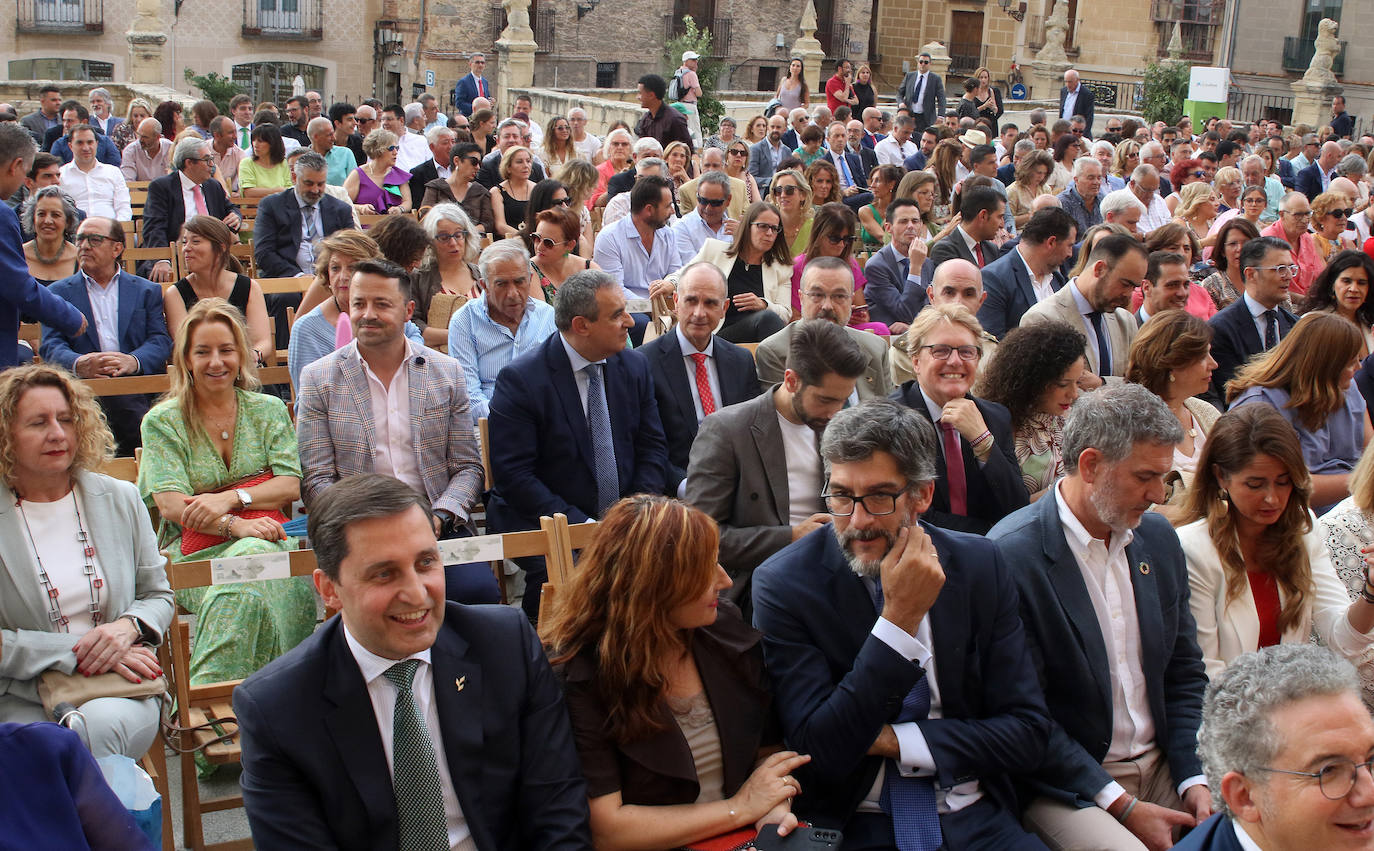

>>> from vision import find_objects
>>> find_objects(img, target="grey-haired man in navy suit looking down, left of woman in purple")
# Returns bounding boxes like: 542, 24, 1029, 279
253, 151, 353, 278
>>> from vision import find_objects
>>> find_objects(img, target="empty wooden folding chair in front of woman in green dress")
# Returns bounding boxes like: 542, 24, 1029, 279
159, 550, 316, 851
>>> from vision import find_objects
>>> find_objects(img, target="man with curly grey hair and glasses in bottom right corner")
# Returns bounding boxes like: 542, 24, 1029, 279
1173, 642, 1374, 851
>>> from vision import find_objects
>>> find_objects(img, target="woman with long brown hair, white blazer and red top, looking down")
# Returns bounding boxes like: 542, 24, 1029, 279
1178, 406, 1374, 676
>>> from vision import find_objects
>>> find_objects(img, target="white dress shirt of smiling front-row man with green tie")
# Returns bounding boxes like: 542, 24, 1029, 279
344, 626, 477, 851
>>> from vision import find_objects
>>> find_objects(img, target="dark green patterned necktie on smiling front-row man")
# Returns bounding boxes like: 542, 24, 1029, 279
382, 659, 448, 851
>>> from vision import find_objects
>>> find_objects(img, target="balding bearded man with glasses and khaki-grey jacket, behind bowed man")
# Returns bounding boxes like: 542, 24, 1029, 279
754, 257, 892, 404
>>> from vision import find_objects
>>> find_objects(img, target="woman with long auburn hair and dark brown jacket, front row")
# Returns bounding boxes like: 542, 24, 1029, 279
540, 494, 811, 848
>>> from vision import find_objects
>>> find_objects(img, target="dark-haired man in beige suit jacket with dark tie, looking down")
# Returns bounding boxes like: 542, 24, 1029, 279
1021, 234, 1149, 389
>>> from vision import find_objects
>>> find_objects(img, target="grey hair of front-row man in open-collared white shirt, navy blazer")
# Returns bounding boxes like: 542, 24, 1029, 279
1063, 384, 1183, 476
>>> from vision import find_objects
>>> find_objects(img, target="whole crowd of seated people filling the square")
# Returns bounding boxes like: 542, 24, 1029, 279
10, 81, 1374, 851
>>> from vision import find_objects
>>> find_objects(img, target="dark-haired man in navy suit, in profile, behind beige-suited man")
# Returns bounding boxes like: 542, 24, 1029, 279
978, 206, 1079, 340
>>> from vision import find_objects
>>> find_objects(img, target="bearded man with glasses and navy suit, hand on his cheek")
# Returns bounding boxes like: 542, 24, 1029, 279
754, 400, 1048, 851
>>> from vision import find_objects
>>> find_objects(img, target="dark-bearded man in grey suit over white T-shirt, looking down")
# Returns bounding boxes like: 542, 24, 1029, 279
686, 319, 868, 608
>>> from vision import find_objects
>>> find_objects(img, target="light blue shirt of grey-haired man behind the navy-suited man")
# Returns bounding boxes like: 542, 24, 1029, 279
448, 296, 555, 421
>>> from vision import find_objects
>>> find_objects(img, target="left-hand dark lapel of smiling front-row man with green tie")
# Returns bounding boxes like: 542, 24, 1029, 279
324, 617, 397, 836
